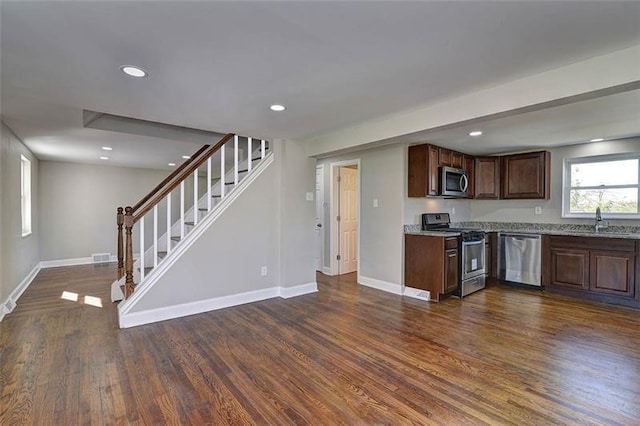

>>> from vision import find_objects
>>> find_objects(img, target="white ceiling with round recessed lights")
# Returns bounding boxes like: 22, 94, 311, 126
0, 1, 640, 168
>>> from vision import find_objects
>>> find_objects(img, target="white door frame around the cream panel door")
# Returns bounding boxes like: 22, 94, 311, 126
325, 158, 362, 281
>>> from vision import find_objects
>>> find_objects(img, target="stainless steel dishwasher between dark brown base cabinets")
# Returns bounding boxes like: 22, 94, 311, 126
498, 232, 542, 286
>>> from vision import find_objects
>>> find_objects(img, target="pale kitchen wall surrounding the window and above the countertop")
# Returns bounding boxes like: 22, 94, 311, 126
470, 138, 640, 226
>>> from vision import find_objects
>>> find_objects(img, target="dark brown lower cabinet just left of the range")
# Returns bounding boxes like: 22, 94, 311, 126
404, 235, 460, 300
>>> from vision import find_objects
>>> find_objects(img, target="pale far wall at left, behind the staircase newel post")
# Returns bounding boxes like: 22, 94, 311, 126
39, 161, 168, 261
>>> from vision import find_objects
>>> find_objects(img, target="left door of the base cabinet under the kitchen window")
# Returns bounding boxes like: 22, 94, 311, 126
549, 247, 589, 290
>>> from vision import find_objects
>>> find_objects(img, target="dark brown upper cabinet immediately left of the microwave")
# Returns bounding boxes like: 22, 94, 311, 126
407, 145, 440, 197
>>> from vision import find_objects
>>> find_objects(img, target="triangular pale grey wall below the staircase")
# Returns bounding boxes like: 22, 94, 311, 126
125, 160, 279, 313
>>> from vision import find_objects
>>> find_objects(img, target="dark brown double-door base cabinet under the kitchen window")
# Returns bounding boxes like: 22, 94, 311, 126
542, 235, 640, 306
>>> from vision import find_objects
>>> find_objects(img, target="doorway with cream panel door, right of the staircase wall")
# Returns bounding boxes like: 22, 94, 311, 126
330, 159, 360, 275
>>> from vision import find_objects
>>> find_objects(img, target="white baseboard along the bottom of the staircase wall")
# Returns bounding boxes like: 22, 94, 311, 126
118, 282, 318, 328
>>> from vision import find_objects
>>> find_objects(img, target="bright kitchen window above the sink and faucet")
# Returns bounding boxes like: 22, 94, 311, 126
562, 153, 640, 219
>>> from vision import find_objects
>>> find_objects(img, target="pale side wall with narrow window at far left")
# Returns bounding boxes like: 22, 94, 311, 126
0, 123, 41, 306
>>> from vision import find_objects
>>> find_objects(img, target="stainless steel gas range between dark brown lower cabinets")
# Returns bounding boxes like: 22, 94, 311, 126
422, 213, 486, 297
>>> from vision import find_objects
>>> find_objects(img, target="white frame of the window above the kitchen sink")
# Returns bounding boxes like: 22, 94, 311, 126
562, 152, 640, 219
